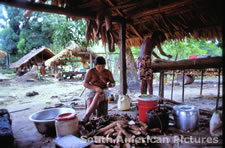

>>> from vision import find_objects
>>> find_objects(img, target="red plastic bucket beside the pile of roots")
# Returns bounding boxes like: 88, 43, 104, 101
138, 99, 158, 123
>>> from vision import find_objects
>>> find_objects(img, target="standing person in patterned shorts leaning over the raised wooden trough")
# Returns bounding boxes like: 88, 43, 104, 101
137, 31, 172, 94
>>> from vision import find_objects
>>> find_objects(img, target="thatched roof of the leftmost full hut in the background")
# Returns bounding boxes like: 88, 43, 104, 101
10, 47, 55, 68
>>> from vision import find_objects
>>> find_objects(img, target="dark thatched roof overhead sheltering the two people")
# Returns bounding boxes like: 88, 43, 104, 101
0, 0, 223, 46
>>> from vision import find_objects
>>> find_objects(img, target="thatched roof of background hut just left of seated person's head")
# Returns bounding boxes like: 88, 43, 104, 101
45, 43, 97, 66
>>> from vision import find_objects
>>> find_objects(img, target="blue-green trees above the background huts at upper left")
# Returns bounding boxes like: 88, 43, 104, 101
0, 5, 86, 65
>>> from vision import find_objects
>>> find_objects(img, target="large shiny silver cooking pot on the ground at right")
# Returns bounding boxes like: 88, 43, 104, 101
173, 105, 199, 132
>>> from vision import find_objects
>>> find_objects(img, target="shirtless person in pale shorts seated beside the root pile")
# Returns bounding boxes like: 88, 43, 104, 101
82, 56, 115, 122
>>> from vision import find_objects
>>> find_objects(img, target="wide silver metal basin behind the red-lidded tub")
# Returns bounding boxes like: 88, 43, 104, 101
29, 108, 75, 136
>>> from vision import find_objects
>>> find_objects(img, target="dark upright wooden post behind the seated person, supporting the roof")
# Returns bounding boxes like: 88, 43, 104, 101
120, 20, 127, 95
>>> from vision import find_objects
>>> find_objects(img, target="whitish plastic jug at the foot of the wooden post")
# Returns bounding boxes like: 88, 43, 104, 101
117, 95, 131, 110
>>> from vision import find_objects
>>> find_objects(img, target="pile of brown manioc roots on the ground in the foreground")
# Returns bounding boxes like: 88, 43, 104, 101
80, 114, 161, 147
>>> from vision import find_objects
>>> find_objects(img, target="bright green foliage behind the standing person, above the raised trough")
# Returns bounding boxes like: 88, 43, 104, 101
131, 38, 222, 60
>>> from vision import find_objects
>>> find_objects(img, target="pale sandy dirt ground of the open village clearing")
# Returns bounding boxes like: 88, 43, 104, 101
0, 75, 222, 148
